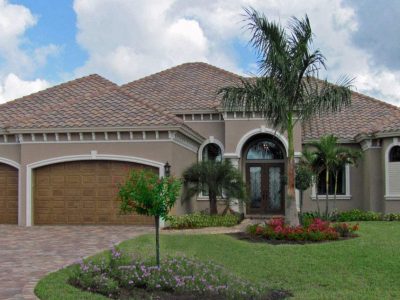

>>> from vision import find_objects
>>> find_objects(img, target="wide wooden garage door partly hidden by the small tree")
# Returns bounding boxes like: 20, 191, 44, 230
33, 161, 155, 225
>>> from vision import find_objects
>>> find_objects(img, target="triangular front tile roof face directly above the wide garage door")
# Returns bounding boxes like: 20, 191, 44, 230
18, 87, 185, 129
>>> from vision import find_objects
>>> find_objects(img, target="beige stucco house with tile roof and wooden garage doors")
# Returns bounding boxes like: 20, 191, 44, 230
0, 63, 400, 226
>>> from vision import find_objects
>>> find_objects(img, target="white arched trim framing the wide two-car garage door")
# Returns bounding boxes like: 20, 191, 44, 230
25, 154, 164, 227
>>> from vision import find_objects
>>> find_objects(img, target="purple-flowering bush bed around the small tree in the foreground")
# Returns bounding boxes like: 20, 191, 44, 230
69, 248, 267, 299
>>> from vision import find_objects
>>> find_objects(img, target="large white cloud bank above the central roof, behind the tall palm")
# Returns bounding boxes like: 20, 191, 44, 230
74, 0, 400, 104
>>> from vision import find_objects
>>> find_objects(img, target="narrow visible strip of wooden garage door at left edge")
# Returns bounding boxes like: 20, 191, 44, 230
0, 163, 18, 224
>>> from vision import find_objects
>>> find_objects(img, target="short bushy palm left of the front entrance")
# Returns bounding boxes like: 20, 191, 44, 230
183, 160, 246, 215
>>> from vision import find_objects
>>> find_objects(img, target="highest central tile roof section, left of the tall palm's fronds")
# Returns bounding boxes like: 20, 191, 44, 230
121, 62, 241, 112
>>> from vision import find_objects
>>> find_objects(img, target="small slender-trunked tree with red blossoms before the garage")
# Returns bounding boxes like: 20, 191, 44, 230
119, 170, 181, 266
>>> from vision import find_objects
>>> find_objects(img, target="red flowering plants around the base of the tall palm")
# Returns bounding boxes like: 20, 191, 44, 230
247, 218, 358, 242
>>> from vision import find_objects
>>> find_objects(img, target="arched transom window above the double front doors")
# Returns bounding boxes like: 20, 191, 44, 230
246, 139, 284, 160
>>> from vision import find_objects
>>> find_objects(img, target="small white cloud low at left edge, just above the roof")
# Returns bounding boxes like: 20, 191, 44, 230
0, 73, 50, 103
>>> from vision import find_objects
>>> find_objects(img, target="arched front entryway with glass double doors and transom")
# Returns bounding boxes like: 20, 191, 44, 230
242, 134, 286, 215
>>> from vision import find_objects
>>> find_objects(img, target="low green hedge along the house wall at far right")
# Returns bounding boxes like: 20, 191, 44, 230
300, 209, 400, 222
